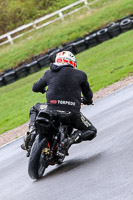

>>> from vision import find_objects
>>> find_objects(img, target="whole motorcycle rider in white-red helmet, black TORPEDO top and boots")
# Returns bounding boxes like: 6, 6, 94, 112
22, 51, 97, 156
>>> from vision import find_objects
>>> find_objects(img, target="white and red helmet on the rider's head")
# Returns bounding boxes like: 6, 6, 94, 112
55, 51, 77, 68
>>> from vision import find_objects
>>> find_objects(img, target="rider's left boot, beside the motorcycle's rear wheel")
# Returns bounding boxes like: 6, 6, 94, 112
21, 126, 36, 157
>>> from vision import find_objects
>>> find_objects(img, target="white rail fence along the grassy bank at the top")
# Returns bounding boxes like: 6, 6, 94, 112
0, 0, 100, 46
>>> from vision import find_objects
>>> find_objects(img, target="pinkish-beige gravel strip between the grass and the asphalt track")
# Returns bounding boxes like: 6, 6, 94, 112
0, 76, 133, 146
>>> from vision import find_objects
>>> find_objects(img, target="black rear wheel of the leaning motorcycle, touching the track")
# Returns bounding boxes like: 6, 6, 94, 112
28, 136, 48, 179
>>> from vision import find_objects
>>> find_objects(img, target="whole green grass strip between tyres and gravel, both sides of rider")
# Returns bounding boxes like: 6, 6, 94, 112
0, 31, 133, 134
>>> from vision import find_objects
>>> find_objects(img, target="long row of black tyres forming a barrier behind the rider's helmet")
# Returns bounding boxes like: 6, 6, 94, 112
0, 15, 133, 87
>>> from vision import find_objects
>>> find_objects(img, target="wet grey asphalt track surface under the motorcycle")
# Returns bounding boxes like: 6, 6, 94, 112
0, 85, 133, 200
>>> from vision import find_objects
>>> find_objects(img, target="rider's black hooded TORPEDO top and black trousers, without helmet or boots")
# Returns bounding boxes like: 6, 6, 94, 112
30, 64, 97, 140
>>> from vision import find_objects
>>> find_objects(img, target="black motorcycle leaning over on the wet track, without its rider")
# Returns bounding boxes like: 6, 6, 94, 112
28, 99, 91, 179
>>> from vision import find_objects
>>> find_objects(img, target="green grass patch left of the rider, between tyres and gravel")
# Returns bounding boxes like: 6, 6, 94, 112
0, 70, 45, 133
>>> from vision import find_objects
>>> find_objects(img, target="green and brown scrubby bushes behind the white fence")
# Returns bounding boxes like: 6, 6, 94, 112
0, 0, 77, 35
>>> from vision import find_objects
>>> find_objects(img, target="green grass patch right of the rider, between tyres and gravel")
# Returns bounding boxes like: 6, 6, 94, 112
78, 31, 133, 92
